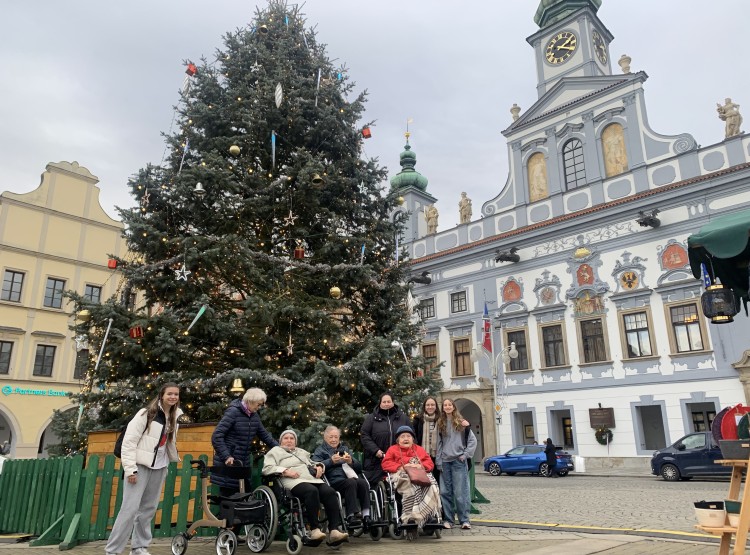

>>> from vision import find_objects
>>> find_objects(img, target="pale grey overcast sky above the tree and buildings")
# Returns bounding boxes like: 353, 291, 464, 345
0, 0, 750, 230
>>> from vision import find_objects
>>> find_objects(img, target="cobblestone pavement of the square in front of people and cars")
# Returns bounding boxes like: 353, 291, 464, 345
0, 473, 740, 555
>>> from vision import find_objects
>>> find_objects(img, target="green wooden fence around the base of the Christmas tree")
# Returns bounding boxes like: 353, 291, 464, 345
0, 455, 487, 550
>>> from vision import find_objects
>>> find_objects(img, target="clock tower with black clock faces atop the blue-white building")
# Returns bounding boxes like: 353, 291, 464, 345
526, 0, 614, 97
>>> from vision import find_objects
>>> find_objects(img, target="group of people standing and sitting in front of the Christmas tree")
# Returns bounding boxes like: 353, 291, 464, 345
105, 383, 477, 555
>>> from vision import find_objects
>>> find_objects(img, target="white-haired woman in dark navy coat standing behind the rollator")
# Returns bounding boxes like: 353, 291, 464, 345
211, 387, 278, 496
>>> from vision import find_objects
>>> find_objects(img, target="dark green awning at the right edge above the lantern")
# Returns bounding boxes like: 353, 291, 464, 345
688, 210, 750, 310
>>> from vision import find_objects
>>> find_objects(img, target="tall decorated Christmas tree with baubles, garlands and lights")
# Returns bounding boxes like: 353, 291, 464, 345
53, 0, 438, 453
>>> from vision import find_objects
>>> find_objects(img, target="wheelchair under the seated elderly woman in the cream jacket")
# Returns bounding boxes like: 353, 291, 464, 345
262, 474, 352, 555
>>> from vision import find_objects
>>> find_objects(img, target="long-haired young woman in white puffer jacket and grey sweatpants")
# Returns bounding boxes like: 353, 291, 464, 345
105, 383, 182, 555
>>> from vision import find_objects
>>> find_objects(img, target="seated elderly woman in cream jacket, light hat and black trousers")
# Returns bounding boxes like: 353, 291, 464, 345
262, 430, 349, 546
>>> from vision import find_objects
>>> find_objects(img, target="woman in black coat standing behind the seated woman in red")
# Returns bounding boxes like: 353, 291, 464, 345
360, 392, 410, 484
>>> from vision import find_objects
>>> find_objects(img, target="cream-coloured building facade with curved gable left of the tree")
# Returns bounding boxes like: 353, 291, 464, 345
0, 162, 126, 458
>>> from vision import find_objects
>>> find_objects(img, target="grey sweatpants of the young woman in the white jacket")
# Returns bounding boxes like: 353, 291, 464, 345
104, 464, 167, 554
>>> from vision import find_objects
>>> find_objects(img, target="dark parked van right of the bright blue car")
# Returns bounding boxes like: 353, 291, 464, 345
651, 432, 732, 482
